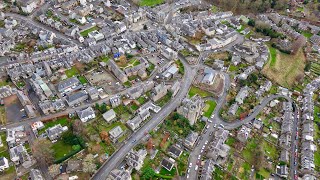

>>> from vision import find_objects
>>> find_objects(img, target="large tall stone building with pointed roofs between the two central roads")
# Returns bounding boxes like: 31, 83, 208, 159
177, 95, 204, 126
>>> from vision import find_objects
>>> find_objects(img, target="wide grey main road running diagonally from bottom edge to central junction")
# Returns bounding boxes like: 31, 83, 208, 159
92, 56, 197, 180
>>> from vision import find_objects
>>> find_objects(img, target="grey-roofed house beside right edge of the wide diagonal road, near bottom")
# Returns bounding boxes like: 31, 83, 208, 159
126, 149, 147, 171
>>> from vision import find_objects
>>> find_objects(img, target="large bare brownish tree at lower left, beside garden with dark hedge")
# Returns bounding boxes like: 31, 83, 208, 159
31, 139, 54, 164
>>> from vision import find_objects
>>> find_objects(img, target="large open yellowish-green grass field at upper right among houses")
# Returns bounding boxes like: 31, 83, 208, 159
262, 50, 306, 88
